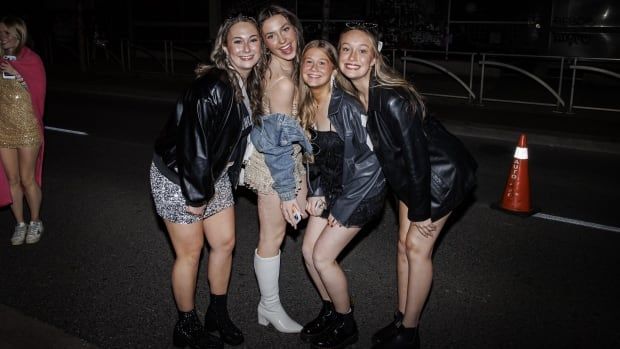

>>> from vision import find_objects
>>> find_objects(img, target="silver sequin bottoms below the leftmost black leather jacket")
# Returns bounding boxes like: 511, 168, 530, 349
151, 164, 235, 224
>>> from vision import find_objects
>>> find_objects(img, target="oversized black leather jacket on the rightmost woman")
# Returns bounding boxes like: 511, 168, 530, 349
367, 80, 477, 222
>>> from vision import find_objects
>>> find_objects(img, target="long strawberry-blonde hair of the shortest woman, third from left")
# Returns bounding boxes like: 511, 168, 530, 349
298, 40, 357, 130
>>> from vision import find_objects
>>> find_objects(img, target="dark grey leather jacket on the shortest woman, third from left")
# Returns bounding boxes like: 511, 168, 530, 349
308, 87, 386, 224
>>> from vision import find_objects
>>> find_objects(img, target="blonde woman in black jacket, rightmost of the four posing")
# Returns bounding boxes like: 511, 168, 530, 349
339, 25, 476, 348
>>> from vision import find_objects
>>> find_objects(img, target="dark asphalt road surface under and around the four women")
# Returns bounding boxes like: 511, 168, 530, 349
0, 86, 620, 348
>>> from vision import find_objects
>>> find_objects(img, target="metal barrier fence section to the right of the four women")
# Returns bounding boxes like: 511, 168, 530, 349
398, 50, 620, 113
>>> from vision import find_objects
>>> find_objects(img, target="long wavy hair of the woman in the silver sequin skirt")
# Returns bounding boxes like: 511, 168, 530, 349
195, 14, 265, 115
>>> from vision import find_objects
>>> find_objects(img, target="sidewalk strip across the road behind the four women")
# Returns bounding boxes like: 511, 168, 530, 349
48, 69, 620, 154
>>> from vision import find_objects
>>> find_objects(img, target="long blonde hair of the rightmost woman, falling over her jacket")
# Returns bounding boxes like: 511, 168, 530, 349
338, 26, 426, 118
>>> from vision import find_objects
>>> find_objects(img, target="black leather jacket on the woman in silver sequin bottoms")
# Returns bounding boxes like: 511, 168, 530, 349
153, 68, 251, 206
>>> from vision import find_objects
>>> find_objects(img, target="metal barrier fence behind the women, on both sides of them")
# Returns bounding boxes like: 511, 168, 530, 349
43, 40, 620, 113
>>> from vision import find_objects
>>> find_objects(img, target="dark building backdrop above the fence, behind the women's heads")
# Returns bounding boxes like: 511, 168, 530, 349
0, 0, 620, 70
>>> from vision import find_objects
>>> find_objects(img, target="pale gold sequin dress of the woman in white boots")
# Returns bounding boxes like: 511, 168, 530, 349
245, 79, 306, 194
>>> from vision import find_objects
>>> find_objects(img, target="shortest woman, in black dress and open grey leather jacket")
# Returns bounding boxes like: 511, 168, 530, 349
300, 40, 386, 348
